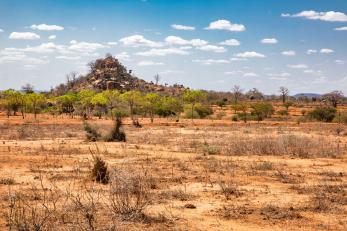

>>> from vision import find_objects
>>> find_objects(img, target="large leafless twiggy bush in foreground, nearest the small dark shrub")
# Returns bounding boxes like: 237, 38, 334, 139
108, 170, 151, 220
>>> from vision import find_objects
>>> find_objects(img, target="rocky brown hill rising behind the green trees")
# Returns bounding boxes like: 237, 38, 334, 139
55, 55, 186, 95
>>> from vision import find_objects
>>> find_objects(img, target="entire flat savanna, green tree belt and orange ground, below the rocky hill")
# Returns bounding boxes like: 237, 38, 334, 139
0, 76, 347, 230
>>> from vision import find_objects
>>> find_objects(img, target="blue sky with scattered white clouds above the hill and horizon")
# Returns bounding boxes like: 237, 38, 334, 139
0, 0, 347, 94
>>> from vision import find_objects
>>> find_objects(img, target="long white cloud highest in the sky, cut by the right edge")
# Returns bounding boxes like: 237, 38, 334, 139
282, 10, 347, 22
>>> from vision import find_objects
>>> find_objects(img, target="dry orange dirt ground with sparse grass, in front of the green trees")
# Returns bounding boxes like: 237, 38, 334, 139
0, 114, 347, 231
